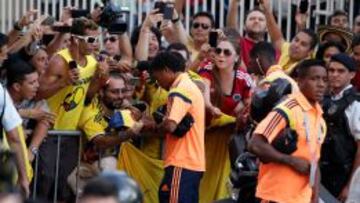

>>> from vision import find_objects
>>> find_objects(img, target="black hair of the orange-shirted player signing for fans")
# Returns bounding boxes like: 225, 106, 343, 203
150, 52, 186, 73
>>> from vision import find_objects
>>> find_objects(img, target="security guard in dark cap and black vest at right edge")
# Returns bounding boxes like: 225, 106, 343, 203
321, 53, 360, 201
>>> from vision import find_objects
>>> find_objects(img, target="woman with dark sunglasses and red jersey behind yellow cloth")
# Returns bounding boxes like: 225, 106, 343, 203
199, 33, 252, 202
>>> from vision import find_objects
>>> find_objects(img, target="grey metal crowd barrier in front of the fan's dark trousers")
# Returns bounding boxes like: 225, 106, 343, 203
27, 130, 82, 203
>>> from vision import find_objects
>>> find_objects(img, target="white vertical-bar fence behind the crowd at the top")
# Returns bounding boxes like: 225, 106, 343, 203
0, 0, 355, 40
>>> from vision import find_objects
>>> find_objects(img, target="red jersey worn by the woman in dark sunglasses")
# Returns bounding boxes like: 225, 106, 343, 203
199, 63, 252, 116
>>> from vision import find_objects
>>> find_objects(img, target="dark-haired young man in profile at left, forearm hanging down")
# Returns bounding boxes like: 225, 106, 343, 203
7, 58, 55, 161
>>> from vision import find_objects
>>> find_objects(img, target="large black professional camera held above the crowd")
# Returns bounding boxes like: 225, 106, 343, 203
99, 0, 127, 34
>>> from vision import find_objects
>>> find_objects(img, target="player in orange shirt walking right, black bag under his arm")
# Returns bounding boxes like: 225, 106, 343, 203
248, 60, 327, 203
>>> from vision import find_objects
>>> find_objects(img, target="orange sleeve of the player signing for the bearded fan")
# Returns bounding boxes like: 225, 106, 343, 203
168, 89, 192, 124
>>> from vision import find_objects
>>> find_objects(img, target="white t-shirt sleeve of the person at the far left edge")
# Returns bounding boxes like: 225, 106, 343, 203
0, 85, 22, 132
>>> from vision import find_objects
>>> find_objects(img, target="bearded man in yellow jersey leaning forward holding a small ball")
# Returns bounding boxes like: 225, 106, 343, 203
68, 72, 154, 192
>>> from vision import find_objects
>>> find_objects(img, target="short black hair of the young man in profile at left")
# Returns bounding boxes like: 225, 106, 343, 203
4, 57, 36, 87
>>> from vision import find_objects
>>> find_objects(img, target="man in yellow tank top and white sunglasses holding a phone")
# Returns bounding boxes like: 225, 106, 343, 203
36, 18, 105, 200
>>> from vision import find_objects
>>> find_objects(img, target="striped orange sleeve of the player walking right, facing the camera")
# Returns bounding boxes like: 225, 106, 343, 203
254, 111, 286, 143
